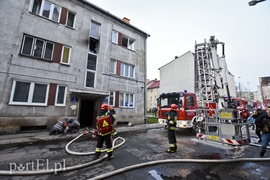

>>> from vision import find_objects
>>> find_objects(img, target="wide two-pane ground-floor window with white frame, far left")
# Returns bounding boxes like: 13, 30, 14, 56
9, 81, 49, 106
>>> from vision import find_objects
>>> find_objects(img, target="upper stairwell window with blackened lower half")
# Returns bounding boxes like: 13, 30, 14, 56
89, 21, 100, 54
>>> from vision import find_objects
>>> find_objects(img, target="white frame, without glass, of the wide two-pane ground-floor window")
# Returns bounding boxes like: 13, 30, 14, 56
9, 80, 50, 106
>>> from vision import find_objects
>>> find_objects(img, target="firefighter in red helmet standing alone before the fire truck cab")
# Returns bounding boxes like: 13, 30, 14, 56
166, 104, 178, 153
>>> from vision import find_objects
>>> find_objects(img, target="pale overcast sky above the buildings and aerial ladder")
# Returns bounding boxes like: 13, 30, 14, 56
89, 0, 270, 91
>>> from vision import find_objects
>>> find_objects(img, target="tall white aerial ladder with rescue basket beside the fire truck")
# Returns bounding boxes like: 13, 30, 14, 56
194, 36, 250, 145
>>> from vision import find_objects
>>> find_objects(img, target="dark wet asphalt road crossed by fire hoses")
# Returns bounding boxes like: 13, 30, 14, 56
0, 128, 270, 180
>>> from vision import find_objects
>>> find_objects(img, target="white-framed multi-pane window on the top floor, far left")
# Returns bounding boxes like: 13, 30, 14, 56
30, 0, 61, 22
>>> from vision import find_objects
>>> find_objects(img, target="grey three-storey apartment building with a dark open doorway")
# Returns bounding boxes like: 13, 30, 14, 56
0, 0, 149, 134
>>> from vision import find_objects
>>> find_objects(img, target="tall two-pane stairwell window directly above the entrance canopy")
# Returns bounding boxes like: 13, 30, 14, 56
85, 53, 97, 87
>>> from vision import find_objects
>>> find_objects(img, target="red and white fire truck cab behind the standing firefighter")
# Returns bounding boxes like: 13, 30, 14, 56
157, 91, 198, 128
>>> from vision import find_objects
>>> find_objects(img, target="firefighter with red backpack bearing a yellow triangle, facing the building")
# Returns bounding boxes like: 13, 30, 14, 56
94, 104, 113, 160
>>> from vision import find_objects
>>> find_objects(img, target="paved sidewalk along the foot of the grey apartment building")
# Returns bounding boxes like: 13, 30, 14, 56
0, 123, 164, 147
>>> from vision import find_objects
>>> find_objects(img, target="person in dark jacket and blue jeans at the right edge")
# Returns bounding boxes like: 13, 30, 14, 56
256, 107, 270, 157
